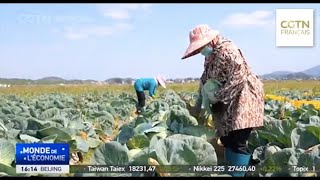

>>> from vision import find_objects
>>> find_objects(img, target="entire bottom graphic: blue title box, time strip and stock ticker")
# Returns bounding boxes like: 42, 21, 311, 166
15, 143, 320, 174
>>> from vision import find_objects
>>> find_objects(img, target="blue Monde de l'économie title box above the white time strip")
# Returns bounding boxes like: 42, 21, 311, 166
16, 143, 69, 165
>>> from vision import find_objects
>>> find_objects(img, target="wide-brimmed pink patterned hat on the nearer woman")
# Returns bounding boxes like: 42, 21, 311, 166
181, 24, 219, 59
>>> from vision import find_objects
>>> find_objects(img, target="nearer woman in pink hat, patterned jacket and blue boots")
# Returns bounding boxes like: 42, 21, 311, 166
182, 25, 264, 176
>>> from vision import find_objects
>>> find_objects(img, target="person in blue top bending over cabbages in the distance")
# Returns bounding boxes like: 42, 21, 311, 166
134, 75, 166, 113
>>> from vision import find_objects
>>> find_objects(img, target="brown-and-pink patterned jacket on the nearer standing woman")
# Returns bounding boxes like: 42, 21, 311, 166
200, 35, 264, 137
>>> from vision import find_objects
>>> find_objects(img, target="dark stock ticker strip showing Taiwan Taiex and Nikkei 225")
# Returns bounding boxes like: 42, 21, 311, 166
70, 165, 319, 174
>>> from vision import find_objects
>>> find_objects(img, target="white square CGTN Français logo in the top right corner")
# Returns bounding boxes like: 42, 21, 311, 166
276, 9, 314, 47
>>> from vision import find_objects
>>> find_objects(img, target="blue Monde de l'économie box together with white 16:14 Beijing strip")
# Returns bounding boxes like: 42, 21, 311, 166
16, 143, 69, 173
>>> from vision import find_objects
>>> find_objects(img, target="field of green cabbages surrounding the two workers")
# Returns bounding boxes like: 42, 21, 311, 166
0, 81, 320, 176
